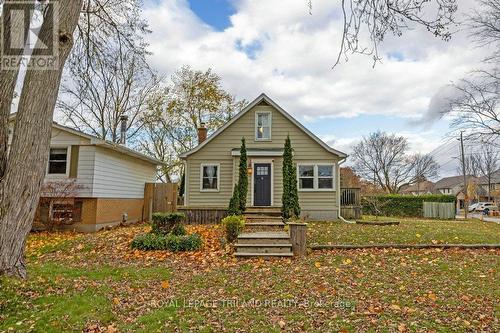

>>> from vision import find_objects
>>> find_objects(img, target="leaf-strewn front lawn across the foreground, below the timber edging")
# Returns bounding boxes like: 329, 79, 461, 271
0, 220, 500, 332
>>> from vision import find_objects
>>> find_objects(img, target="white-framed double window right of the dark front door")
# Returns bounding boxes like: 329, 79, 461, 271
297, 164, 335, 191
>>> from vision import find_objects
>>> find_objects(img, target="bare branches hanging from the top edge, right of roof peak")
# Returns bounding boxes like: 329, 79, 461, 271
308, 0, 457, 66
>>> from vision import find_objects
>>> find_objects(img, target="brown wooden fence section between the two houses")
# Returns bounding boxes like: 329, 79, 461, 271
143, 183, 177, 221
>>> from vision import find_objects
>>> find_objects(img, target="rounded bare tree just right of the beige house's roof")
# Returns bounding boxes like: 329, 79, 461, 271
353, 132, 438, 193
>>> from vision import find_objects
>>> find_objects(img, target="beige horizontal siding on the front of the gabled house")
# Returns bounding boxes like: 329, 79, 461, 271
186, 105, 339, 219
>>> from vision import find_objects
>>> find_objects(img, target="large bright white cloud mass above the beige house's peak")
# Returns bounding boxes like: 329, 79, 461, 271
145, 0, 483, 118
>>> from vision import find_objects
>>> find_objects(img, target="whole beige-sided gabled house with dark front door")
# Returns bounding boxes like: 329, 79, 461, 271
181, 94, 347, 220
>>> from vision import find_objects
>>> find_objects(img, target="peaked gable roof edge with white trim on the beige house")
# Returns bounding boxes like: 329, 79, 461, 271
180, 93, 347, 158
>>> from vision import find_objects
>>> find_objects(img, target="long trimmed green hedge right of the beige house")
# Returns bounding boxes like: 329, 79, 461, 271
361, 194, 456, 217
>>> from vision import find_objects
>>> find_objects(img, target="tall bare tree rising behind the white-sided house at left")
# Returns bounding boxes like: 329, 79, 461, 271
58, 0, 155, 142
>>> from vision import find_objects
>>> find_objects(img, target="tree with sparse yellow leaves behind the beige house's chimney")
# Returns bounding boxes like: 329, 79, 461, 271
139, 66, 246, 181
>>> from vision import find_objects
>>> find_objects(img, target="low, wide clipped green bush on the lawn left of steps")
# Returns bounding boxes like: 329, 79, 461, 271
132, 233, 203, 252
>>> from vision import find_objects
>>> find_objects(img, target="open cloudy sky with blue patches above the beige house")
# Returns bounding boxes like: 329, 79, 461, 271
140, 0, 488, 175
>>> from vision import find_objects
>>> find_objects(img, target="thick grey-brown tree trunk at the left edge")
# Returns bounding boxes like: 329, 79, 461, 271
0, 0, 82, 277
